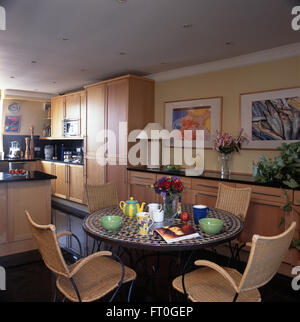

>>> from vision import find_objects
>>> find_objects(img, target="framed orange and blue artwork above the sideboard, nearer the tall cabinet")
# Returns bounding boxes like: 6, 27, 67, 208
164, 96, 223, 149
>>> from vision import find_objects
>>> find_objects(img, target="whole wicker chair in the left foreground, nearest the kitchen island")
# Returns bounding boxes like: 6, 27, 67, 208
25, 211, 136, 302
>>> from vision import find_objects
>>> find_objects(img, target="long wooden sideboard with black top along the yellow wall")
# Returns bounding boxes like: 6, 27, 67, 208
127, 167, 300, 266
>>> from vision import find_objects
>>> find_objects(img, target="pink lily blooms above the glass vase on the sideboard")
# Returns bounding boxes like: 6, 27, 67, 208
214, 129, 249, 154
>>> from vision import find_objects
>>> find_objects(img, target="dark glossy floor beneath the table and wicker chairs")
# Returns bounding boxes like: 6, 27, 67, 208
0, 251, 300, 302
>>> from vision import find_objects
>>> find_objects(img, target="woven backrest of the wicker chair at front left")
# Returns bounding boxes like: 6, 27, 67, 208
25, 211, 69, 277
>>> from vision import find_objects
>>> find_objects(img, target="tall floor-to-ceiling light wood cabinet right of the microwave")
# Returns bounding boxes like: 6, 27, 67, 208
85, 75, 154, 200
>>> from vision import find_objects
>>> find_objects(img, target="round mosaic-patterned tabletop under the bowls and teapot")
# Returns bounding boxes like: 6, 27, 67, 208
83, 204, 243, 251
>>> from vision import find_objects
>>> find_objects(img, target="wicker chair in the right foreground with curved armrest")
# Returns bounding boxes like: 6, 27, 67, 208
173, 222, 296, 302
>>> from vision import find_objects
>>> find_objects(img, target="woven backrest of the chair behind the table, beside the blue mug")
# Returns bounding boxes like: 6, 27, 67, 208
215, 183, 251, 221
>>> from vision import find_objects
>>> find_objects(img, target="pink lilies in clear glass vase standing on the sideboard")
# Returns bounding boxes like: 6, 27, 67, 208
214, 129, 248, 179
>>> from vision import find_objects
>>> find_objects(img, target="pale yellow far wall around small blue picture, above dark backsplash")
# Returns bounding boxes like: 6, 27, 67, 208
2, 99, 45, 135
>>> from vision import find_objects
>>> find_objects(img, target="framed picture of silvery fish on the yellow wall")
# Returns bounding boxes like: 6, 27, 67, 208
240, 87, 300, 150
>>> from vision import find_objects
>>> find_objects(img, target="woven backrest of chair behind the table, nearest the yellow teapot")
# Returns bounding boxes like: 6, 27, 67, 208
85, 182, 119, 213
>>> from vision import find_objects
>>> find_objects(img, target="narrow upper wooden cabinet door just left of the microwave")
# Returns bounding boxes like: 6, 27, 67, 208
51, 97, 65, 138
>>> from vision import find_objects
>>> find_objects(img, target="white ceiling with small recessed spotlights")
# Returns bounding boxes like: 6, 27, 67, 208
0, 0, 300, 93
